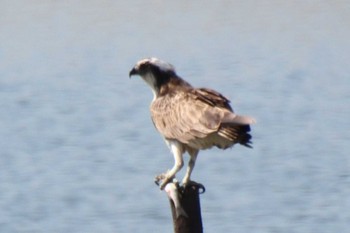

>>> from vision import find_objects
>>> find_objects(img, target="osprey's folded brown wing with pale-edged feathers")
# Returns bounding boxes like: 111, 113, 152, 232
151, 88, 252, 147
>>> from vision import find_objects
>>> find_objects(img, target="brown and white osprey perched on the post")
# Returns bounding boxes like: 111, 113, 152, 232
129, 58, 254, 189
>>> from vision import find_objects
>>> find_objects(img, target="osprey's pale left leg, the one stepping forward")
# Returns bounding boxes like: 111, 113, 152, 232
160, 142, 184, 190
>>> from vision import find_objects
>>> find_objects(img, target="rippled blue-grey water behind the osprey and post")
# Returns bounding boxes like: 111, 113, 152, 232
0, 0, 350, 233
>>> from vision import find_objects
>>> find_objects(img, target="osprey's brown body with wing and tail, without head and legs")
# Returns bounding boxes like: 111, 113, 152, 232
151, 79, 253, 149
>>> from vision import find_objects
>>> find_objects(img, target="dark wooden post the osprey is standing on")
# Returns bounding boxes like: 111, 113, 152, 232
165, 182, 205, 233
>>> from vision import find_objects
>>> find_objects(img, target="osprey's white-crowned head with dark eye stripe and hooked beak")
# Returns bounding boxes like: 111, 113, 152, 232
129, 58, 176, 95
